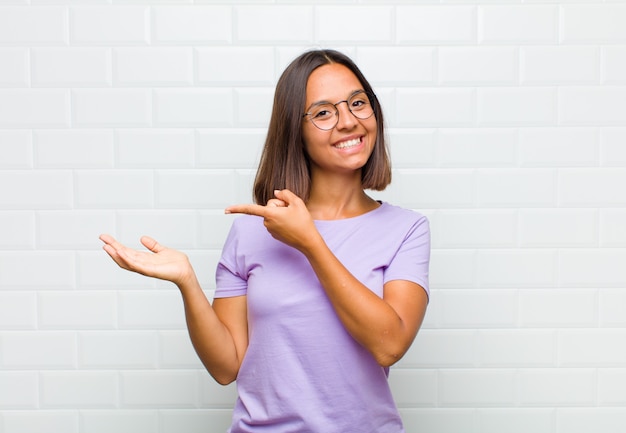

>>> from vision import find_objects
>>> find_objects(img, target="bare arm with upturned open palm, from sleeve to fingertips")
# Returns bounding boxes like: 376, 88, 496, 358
100, 235, 248, 385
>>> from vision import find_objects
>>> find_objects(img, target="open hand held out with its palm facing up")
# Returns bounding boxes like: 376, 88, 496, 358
100, 234, 194, 286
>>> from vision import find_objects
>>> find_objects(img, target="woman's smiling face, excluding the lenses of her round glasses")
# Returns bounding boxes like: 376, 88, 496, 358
302, 63, 376, 175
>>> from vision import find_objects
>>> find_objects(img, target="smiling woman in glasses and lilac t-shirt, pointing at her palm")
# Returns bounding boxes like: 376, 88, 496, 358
101, 50, 430, 433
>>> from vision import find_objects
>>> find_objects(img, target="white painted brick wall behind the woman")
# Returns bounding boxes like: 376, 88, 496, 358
0, 0, 626, 433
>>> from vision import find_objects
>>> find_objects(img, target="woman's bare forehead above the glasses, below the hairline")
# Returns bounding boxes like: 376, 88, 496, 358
306, 63, 363, 105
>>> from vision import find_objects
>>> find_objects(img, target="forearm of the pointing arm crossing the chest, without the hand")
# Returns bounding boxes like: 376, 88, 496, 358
302, 237, 415, 366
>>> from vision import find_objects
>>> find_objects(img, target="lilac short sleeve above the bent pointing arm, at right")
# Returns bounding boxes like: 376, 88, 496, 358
384, 215, 430, 296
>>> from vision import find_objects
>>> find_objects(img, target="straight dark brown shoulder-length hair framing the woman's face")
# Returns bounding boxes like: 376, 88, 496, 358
253, 50, 391, 205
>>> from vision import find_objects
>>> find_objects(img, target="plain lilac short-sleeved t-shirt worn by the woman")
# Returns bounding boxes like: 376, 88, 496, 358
215, 203, 430, 433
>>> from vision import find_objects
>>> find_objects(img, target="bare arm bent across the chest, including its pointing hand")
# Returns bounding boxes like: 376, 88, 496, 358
226, 190, 428, 367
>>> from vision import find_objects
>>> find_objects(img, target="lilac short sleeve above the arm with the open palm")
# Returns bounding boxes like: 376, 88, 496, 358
214, 221, 248, 298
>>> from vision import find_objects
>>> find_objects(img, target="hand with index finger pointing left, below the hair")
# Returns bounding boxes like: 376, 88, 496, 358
226, 189, 321, 252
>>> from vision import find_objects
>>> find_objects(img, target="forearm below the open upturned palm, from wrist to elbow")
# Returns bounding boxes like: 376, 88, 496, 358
178, 276, 240, 385
